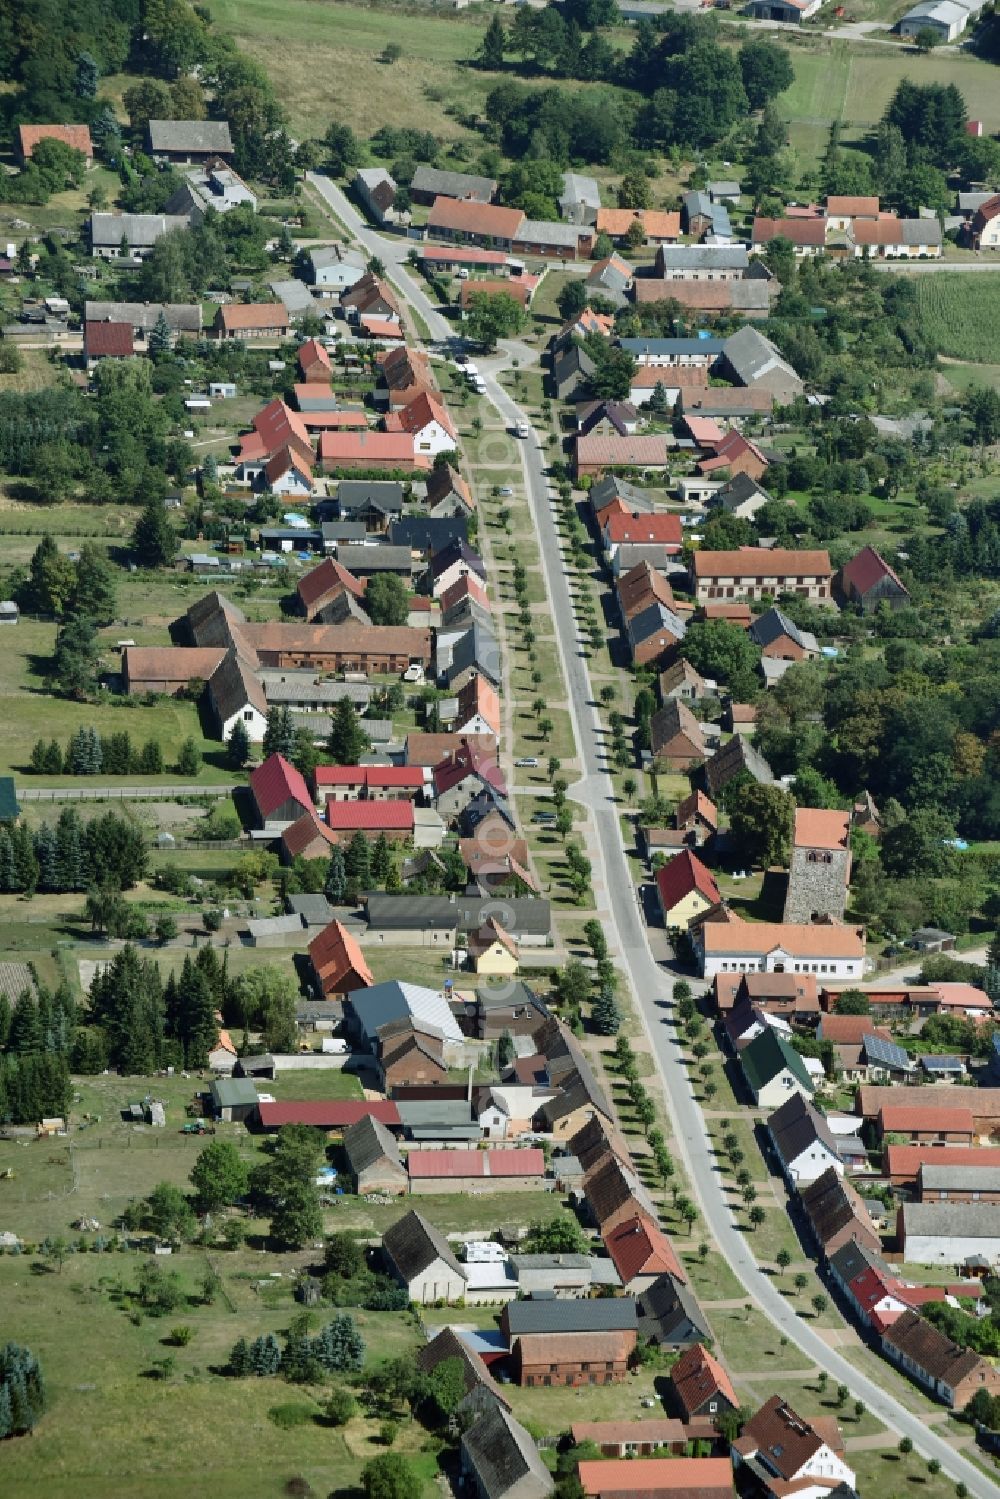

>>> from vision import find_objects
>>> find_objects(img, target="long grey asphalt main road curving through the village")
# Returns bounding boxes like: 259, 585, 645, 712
301, 184, 1000, 1499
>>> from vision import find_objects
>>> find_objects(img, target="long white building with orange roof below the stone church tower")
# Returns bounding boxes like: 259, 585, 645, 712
697, 920, 865, 982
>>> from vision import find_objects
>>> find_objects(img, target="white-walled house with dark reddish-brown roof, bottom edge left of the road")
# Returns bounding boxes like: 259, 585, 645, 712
732, 1396, 856, 1499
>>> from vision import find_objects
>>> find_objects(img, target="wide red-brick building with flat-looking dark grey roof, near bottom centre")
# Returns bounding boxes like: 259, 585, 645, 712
501, 1297, 636, 1388
